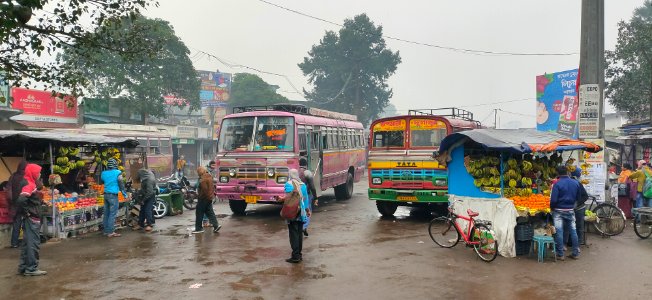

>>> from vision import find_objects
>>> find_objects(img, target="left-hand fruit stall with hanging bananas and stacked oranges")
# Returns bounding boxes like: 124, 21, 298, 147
0, 130, 138, 243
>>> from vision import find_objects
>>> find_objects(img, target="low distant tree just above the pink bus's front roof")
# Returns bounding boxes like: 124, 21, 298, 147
229, 73, 288, 107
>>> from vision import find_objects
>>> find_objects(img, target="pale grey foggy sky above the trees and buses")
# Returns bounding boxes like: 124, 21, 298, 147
145, 0, 643, 128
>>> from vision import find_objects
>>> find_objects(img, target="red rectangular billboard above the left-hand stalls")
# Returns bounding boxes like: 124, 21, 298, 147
11, 88, 77, 123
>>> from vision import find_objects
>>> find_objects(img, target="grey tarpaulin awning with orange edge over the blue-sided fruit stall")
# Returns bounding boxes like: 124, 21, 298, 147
439, 128, 602, 153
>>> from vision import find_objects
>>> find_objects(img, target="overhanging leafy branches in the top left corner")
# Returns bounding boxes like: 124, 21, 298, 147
0, 0, 158, 92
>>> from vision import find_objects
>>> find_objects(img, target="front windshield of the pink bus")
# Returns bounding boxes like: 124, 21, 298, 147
219, 117, 294, 151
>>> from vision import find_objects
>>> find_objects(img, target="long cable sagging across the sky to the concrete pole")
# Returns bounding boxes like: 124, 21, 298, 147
258, 0, 579, 56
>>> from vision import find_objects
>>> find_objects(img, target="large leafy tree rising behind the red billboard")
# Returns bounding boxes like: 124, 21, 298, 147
62, 16, 200, 122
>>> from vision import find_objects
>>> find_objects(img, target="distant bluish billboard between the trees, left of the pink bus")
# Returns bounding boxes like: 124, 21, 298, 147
197, 71, 231, 107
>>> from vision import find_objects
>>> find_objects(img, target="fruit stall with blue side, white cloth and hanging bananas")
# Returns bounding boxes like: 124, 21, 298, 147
436, 129, 602, 256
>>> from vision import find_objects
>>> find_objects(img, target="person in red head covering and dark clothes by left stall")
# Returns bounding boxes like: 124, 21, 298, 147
16, 164, 47, 276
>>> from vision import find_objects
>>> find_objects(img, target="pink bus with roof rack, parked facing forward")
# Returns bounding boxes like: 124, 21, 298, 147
215, 104, 366, 215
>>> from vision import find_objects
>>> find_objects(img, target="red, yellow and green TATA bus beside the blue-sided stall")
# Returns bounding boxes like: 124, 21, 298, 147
368, 108, 480, 216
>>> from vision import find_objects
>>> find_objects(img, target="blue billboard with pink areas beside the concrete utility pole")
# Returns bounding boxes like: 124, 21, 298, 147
536, 69, 579, 138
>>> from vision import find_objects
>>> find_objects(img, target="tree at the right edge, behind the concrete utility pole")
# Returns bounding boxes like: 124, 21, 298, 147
605, 0, 652, 121
